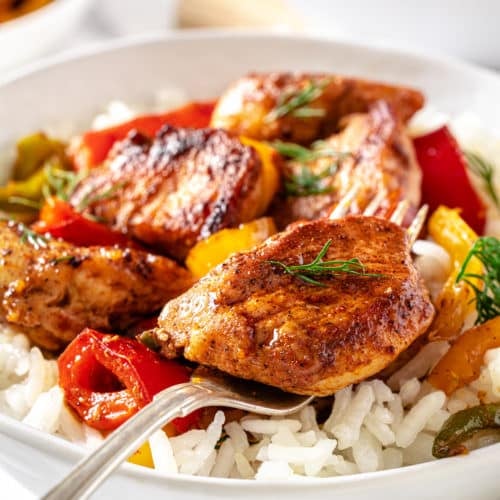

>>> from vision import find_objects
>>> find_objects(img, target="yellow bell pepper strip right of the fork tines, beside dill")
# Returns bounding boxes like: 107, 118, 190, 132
429, 206, 483, 341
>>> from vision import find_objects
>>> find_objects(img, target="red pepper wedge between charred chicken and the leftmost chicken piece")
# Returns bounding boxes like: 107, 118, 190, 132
33, 197, 136, 248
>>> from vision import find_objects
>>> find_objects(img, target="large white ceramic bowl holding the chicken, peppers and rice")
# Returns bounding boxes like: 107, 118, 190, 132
0, 33, 500, 500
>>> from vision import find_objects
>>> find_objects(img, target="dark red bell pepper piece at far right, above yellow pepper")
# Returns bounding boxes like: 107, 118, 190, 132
413, 127, 486, 234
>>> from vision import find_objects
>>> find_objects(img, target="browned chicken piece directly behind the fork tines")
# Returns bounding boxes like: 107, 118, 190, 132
272, 101, 422, 227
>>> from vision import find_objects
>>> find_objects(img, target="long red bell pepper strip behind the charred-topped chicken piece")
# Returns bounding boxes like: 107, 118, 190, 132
72, 101, 215, 169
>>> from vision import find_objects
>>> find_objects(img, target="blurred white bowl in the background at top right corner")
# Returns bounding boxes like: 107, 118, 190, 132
287, 0, 500, 68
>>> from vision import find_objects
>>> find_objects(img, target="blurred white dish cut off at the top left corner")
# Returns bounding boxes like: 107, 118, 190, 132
0, 0, 92, 74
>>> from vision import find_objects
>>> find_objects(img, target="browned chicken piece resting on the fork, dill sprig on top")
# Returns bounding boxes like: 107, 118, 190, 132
149, 216, 434, 396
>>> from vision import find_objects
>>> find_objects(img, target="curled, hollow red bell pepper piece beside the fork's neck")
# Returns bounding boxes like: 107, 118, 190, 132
58, 328, 200, 433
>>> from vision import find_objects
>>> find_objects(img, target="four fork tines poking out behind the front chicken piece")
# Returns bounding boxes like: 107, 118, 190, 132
328, 182, 429, 248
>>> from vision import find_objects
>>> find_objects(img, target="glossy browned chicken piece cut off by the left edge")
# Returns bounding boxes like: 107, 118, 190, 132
0, 222, 193, 350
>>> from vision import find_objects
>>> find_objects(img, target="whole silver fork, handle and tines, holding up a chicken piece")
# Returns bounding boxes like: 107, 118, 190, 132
42, 188, 427, 500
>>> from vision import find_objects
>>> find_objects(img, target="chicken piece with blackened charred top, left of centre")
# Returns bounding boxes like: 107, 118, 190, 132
70, 126, 278, 260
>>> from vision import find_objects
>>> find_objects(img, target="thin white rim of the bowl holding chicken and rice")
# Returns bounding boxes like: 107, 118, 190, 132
0, 30, 500, 492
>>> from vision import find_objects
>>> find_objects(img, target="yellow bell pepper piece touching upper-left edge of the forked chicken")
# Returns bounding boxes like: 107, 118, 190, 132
186, 217, 276, 278
